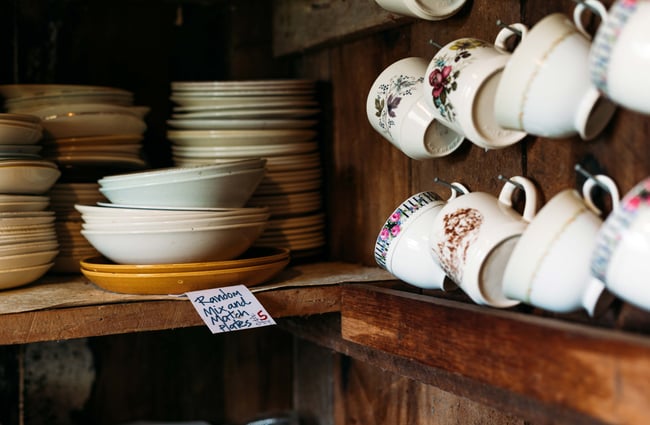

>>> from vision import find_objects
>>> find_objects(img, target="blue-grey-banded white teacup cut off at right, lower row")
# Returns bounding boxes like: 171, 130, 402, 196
591, 177, 650, 310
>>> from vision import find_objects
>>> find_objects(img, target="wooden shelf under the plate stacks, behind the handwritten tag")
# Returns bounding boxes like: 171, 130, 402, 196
0, 262, 392, 345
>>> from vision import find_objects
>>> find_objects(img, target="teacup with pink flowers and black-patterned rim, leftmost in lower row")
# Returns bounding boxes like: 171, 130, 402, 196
375, 183, 467, 290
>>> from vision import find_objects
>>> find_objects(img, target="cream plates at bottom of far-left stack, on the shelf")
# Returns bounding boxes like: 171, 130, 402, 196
0, 210, 58, 289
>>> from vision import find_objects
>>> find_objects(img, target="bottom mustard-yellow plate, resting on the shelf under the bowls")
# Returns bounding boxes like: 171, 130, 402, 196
81, 257, 289, 295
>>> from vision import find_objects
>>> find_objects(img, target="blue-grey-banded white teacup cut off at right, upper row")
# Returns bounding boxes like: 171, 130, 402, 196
589, 0, 650, 114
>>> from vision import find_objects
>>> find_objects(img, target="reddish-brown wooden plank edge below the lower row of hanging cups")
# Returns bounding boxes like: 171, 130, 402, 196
341, 285, 650, 424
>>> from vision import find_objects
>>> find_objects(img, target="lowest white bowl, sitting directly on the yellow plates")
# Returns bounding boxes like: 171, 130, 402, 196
81, 221, 266, 264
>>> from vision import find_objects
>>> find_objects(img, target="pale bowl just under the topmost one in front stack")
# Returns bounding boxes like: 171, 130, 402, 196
99, 168, 266, 208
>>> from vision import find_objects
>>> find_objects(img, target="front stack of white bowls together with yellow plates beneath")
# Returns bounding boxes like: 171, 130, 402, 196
75, 158, 288, 293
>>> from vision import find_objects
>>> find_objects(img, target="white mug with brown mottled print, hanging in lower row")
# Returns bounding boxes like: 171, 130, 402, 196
429, 176, 537, 308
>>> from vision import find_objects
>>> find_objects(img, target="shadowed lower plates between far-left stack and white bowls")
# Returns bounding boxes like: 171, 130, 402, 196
49, 183, 106, 273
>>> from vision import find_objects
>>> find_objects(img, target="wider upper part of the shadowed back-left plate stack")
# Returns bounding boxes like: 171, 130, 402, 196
0, 84, 149, 182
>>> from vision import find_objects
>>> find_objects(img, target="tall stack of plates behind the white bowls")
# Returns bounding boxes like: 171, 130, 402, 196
167, 79, 325, 258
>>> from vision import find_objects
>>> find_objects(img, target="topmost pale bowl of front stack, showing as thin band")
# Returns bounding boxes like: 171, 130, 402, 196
97, 158, 266, 188
